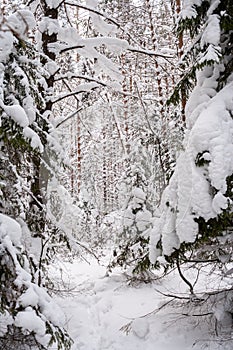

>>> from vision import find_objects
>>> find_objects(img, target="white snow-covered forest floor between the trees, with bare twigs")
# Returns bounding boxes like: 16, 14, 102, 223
51, 255, 233, 350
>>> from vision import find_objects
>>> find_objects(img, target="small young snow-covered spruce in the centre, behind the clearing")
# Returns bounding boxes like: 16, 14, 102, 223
109, 138, 158, 280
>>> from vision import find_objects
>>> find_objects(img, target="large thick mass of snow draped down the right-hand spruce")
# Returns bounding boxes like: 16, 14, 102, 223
150, 65, 233, 263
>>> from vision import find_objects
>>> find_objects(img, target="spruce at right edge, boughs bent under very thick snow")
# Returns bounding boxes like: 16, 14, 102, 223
150, 0, 233, 312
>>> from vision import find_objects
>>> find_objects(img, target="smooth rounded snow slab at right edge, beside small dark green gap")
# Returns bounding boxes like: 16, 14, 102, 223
190, 79, 233, 194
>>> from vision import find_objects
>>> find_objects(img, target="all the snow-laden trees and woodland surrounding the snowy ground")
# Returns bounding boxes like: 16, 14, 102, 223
0, 0, 233, 350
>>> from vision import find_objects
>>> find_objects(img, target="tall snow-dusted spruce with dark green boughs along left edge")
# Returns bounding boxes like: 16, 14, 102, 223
0, 10, 71, 350
